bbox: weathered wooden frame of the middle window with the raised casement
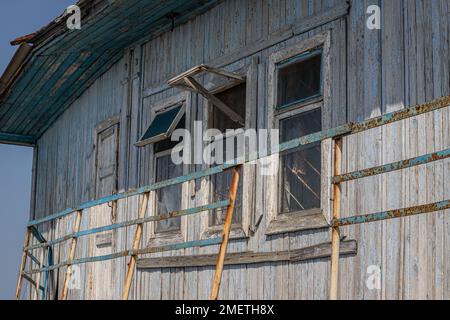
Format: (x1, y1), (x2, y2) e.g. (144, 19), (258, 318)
(200, 58), (259, 239)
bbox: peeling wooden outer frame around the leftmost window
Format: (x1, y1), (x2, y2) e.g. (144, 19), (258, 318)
(144, 93), (190, 247)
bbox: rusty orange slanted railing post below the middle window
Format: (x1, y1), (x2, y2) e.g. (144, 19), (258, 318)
(211, 166), (241, 300)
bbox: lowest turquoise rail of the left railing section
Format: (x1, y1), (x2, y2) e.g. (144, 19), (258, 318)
(24, 237), (222, 275)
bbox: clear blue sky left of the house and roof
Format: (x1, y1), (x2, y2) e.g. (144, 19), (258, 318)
(0, 0), (76, 299)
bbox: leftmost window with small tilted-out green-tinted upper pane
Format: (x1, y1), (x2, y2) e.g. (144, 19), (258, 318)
(135, 94), (189, 241)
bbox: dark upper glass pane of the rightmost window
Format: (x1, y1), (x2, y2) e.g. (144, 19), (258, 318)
(277, 53), (322, 108)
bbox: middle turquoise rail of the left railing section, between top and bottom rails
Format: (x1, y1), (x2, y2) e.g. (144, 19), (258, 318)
(23, 200), (230, 251)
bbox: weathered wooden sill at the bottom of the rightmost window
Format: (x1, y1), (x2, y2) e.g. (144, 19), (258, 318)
(265, 209), (329, 236)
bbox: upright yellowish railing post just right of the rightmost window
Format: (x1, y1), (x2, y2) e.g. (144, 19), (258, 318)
(330, 138), (342, 300)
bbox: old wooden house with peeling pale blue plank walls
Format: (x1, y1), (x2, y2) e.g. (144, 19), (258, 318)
(0, 0), (450, 299)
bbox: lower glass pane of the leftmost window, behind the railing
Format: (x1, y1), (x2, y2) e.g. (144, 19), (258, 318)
(155, 154), (183, 232)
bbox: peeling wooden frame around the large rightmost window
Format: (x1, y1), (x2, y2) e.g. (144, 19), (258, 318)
(266, 31), (331, 236)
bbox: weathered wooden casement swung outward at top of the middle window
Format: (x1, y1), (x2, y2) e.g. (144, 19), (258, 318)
(168, 64), (245, 127)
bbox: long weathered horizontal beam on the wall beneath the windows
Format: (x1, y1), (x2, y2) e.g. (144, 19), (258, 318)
(136, 240), (357, 269)
